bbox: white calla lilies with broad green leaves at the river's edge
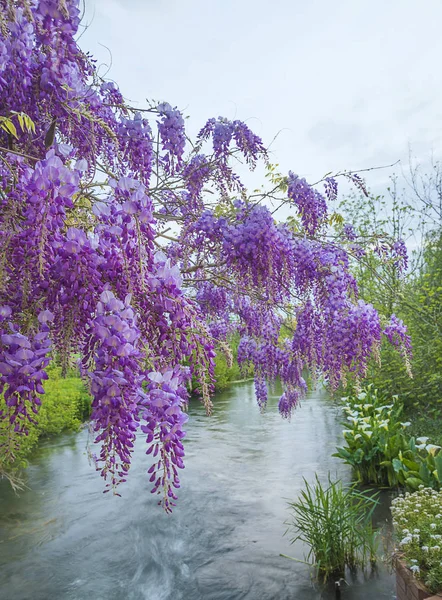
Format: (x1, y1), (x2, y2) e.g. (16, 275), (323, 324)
(334, 385), (442, 490)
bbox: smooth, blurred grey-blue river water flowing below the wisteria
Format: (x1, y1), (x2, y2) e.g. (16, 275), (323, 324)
(0, 382), (395, 600)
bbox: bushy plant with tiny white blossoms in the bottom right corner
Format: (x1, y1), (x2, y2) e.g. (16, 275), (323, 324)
(391, 486), (442, 593)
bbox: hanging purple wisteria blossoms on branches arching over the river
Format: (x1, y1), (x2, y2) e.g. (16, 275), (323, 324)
(0, 0), (410, 511)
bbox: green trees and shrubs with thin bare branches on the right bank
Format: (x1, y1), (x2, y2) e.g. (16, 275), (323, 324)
(341, 185), (442, 444)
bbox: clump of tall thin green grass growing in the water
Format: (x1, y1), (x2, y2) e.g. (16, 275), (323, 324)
(287, 475), (377, 579)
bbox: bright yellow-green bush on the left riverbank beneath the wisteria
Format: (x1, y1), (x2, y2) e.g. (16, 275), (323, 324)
(0, 367), (91, 478)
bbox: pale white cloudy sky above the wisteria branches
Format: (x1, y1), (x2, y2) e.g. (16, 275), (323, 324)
(80, 0), (442, 193)
